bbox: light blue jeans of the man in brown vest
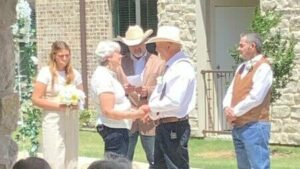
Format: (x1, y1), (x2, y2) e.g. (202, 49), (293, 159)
(232, 122), (271, 169)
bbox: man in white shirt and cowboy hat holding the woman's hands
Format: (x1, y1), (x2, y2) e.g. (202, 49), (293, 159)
(140, 26), (196, 169)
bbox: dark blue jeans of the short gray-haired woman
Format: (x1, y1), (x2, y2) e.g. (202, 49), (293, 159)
(96, 125), (129, 157)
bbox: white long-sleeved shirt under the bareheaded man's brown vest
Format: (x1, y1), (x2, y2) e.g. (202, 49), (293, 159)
(223, 54), (273, 117)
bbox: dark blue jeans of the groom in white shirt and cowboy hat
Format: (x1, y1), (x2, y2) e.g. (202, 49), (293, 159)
(154, 120), (191, 169)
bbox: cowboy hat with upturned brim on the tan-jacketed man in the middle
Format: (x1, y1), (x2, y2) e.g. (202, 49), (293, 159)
(118, 25), (153, 46)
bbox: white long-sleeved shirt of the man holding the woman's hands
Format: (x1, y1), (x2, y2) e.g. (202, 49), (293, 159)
(149, 51), (196, 120)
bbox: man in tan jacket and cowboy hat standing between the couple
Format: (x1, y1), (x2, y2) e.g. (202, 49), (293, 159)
(119, 25), (165, 168)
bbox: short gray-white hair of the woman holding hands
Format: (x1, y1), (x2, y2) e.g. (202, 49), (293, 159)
(95, 40), (121, 65)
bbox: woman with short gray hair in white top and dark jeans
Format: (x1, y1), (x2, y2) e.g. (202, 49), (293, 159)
(91, 40), (145, 156)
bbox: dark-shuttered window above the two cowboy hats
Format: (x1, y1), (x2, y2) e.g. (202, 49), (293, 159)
(113, 0), (157, 36)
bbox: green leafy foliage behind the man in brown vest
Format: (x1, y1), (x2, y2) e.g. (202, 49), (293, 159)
(230, 9), (296, 102)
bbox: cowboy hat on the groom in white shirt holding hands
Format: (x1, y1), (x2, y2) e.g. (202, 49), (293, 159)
(146, 26), (181, 45)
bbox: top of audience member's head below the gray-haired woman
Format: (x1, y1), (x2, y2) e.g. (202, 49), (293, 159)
(88, 152), (132, 169)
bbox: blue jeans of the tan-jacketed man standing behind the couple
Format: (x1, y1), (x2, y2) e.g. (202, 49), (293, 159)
(127, 131), (155, 169)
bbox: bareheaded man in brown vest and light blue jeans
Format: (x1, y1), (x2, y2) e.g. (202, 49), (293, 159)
(223, 33), (273, 169)
